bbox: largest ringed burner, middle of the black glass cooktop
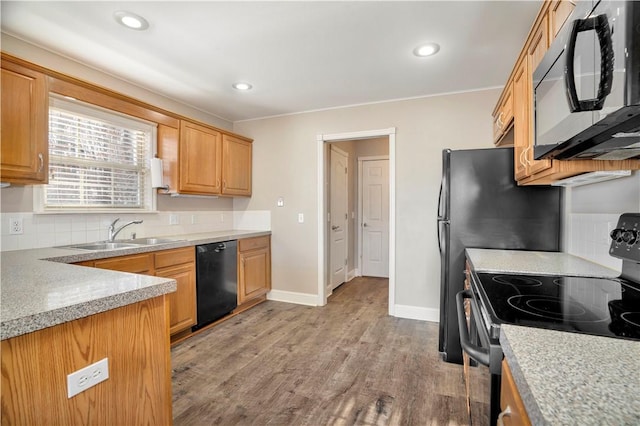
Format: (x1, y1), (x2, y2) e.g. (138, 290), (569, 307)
(507, 294), (608, 322)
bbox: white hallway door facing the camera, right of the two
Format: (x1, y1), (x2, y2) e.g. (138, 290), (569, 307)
(360, 160), (389, 277)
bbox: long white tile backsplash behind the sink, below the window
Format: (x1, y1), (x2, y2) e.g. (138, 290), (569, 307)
(0, 211), (271, 251)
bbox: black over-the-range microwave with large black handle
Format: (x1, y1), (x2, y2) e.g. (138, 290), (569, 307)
(532, 0), (640, 160)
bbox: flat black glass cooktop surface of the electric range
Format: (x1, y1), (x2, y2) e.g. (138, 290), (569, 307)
(477, 273), (640, 340)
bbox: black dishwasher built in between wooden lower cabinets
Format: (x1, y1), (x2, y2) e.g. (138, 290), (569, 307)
(192, 240), (238, 331)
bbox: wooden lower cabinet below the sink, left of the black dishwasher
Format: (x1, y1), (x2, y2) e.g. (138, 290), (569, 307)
(85, 247), (197, 334)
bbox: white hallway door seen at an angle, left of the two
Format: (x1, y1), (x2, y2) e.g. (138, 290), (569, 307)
(328, 146), (349, 292)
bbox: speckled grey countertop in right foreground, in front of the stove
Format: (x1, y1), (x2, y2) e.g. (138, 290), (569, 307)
(500, 324), (640, 425)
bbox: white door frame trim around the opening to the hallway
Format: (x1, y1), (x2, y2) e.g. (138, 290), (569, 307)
(316, 127), (396, 316)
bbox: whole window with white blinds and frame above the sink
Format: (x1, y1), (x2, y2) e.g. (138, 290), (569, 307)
(39, 96), (156, 212)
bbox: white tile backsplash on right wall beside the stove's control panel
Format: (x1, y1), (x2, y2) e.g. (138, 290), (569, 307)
(565, 213), (622, 272)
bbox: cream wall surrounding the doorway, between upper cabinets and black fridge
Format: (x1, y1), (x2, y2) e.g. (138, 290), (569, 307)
(234, 90), (499, 317)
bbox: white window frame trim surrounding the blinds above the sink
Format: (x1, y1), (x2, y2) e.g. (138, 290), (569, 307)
(33, 93), (158, 214)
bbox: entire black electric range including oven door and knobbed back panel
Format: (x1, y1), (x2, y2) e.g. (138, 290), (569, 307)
(457, 213), (640, 424)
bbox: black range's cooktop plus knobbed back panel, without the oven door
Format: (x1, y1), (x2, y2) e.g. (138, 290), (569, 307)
(472, 213), (640, 340)
